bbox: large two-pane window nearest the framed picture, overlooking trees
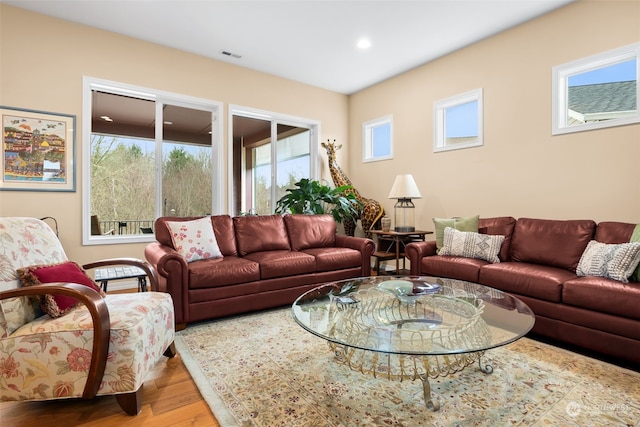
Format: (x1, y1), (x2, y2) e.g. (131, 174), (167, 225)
(82, 78), (222, 245)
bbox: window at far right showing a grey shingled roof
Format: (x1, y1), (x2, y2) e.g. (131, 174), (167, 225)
(552, 43), (640, 135)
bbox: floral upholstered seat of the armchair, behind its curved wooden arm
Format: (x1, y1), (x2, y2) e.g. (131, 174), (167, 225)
(0, 292), (175, 400)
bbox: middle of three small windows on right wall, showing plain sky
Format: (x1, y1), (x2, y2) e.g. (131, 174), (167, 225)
(433, 89), (483, 152)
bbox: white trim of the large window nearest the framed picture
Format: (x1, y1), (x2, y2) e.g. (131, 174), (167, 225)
(82, 76), (224, 245)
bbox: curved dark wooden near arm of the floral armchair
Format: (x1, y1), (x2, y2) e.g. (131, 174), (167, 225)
(0, 282), (111, 399)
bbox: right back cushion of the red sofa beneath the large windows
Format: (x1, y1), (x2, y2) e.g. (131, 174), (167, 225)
(284, 214), (336, 251)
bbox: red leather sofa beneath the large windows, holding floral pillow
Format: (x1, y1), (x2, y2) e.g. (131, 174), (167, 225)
(145, 215), (375, 330)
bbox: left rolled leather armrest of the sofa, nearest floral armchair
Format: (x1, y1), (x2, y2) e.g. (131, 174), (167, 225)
(144, 242), (189, 325)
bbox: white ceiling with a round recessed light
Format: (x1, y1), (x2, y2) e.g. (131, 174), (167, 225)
(5, 0), (574, 94)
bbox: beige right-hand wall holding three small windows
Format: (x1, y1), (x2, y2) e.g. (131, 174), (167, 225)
(348, 1), (640, 234)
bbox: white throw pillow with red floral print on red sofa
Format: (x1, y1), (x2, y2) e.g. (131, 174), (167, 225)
(166, 217), (222, 262)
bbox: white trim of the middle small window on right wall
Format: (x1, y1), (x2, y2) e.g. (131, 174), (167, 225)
(433, 88), (484, 153)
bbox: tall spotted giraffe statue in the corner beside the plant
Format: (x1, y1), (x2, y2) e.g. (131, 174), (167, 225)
(321, 140), (384, 238)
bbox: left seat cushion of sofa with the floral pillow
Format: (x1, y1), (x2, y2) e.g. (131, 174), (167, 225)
(188, 256), (260, 289)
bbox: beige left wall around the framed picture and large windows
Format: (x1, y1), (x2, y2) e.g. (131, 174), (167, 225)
(0, 4), (348, 263)
